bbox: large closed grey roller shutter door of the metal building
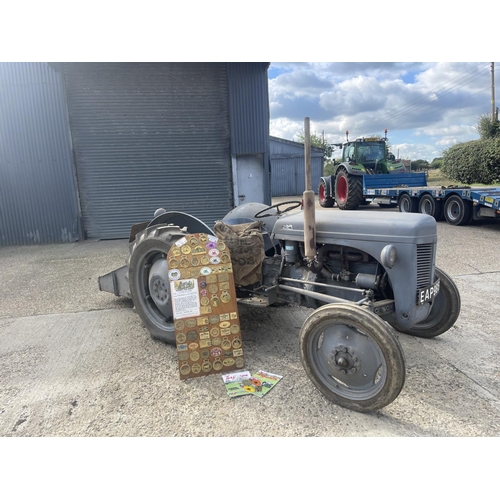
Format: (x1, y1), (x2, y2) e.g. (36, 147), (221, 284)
(63, 63), (233, 239)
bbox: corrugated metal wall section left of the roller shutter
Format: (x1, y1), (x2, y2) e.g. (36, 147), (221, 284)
(0, 62), (81, 245)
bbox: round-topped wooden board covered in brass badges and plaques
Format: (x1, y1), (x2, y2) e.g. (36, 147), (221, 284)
(167, 233), (245, 379)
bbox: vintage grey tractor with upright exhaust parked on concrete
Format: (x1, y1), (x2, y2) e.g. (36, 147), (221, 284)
(99, 118), (460, 412)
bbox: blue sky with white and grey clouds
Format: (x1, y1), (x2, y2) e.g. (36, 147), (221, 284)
(268, 62), (500, 162)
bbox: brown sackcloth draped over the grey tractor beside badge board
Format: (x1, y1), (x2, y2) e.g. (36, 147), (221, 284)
(214, 221), (265, 286)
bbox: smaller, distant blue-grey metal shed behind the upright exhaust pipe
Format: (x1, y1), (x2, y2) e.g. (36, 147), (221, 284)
(269, 137), (324, 196)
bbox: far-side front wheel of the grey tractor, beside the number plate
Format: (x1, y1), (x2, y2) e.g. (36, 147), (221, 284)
(393, 267), (461, 339)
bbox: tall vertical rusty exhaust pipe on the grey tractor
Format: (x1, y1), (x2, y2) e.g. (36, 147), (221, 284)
(303, 117), (316, 265)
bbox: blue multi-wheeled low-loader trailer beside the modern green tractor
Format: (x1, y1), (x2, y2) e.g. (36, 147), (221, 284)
(363, 172), (500, 226)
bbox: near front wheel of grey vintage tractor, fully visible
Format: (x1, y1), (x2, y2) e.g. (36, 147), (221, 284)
(300, 304), (405, 412)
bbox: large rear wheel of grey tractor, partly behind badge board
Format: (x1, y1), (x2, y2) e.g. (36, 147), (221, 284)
(128, 226), (186, 344)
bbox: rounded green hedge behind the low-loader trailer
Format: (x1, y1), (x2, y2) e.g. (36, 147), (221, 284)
(441, 138), (500, 184)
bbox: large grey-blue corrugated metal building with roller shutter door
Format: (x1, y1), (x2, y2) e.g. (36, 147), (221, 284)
(0, 63), (271, 245)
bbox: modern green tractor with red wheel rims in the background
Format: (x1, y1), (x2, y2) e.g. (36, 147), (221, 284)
(318, 129), (406, 210)
